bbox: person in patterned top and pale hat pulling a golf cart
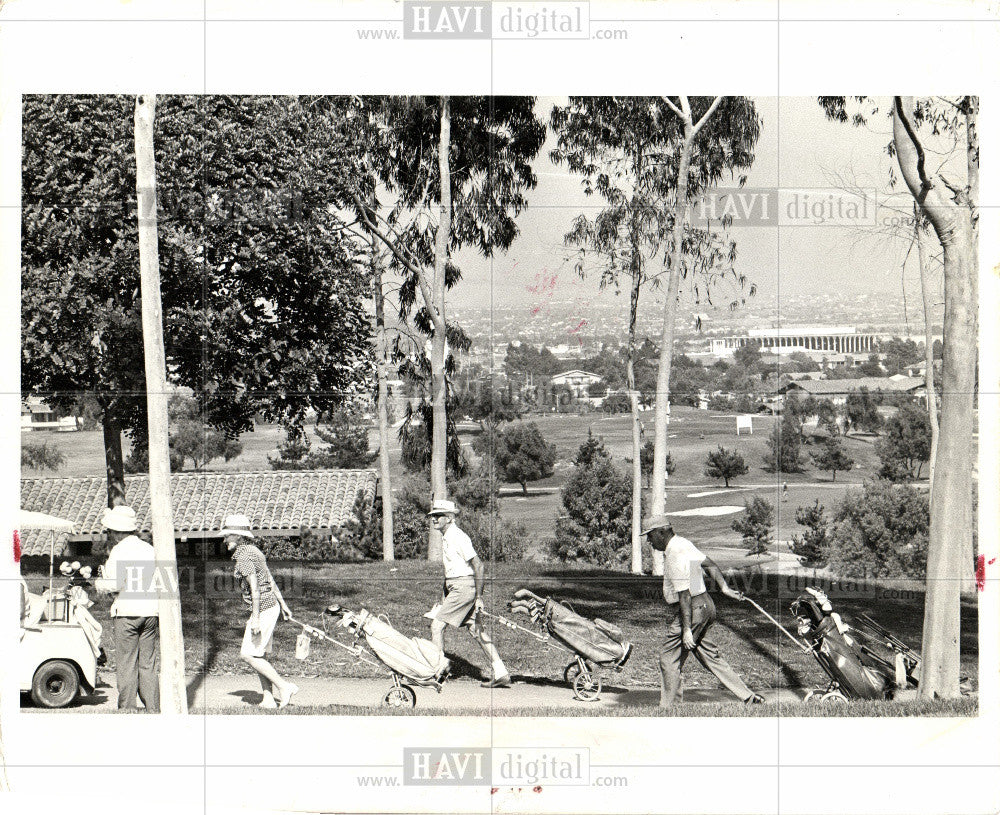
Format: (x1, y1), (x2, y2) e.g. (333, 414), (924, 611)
(220, 515), (299, 709)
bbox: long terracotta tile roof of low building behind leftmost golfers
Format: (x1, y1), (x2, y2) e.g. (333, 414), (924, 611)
(21, 470), (377, 555)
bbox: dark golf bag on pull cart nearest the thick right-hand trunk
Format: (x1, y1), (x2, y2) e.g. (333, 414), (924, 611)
(791, 588), (904, 699)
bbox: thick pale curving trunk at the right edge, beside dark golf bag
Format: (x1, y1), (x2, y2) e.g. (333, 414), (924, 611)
(893, 92), (979, 698)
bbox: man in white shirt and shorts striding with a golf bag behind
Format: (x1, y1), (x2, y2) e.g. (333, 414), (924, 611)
(424, 501), (511, 688)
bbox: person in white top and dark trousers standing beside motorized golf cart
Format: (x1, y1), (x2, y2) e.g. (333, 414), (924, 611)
(94, 506), (160, 713)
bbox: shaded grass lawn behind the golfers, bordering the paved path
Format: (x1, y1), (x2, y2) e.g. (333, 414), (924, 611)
(29, 561), (977, 700)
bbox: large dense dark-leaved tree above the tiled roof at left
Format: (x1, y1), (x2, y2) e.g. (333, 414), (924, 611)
(21, 96), (369, 504)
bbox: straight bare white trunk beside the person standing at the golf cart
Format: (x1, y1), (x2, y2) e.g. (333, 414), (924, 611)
(135, 94), (187, 714)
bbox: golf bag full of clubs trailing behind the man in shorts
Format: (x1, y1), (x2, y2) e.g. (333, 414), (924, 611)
(510, 589), (632, 668)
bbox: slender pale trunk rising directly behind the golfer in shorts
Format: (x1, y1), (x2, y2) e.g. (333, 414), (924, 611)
(427, 96), (451, 561)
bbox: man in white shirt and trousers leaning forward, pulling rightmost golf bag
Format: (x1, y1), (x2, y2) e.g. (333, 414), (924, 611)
(643, 515), (764, 708)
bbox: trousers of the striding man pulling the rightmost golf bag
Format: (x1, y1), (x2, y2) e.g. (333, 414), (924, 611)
(660, 592), (753, 707)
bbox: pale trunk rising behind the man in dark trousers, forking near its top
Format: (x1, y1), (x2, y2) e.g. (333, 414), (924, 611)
(649, 132), (694, 575)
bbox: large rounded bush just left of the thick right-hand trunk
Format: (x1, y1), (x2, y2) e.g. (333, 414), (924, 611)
(827, 479), (930, 578)
